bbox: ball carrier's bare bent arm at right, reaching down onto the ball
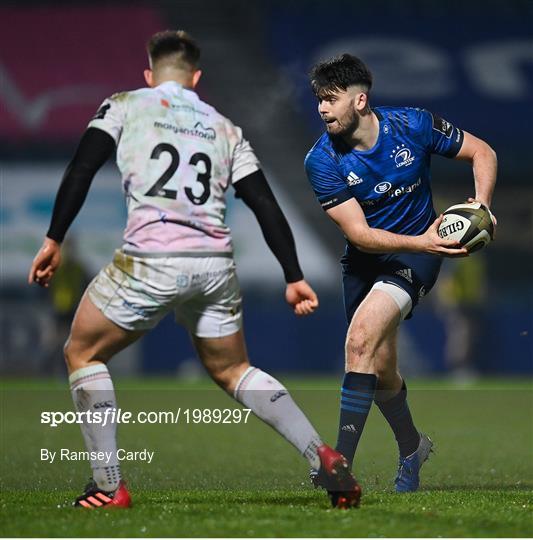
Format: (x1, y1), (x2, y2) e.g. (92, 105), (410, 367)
(455, 131), (498, 221)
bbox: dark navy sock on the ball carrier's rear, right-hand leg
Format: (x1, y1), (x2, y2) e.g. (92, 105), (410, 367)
(376, 381), (420, 457)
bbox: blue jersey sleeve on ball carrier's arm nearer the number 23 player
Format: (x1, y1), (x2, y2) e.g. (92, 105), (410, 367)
(304, 149), (353, 210)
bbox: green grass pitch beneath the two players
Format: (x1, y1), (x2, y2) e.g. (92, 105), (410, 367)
(0, 379), (533, 537)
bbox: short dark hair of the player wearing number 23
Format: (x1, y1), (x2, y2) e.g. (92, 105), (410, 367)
(147, 30), (200, 71)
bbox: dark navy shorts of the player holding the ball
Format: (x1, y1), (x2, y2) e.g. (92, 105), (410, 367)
(341, 246), (442, 323)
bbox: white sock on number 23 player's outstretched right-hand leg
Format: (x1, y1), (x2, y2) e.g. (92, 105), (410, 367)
(233, 367), (323, 470)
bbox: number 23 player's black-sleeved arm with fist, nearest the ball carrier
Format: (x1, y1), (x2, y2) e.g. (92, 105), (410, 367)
(234, 169), (318, 315)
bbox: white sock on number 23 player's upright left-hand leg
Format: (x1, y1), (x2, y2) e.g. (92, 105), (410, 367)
(69, 364), (121, 491)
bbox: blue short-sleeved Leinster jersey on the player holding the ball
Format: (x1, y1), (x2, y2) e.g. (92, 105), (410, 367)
(305, 107), (463, 235)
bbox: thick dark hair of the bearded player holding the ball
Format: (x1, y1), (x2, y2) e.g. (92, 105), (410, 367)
(309, 54), (372, 97)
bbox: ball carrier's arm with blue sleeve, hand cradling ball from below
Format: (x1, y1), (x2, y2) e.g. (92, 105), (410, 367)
(305, 150), (467, 257)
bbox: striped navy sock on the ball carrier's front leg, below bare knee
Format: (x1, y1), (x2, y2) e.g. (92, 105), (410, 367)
(336, 371), (378, 463)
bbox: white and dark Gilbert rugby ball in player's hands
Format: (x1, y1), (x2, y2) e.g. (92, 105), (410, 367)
(439, 202), (494, 253)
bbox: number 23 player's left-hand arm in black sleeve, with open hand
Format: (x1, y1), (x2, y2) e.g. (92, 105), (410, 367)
(28, 127), (115, 287)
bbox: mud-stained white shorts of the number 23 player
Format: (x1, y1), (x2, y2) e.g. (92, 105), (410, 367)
(87, 250), (242, 338)
